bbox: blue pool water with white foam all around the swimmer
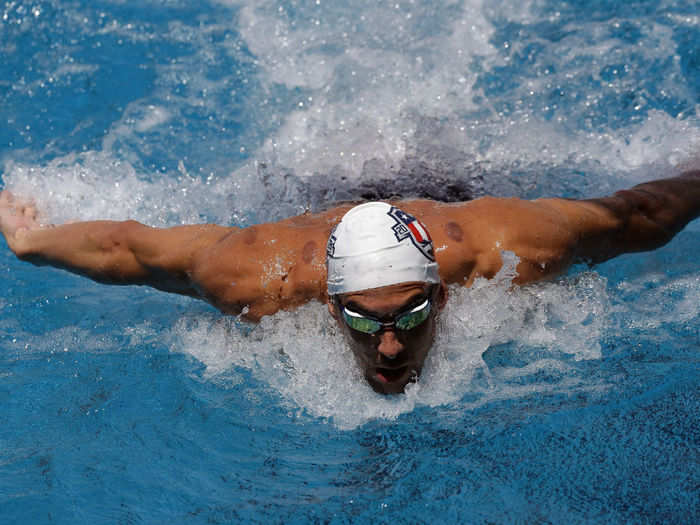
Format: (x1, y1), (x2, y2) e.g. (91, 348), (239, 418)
(0, 0), (700, 524)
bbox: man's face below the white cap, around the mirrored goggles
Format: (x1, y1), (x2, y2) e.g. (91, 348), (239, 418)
(328, 282), (447, 394)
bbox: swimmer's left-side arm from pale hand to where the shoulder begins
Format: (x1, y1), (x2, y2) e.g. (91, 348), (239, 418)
(0, 191), (230, 296)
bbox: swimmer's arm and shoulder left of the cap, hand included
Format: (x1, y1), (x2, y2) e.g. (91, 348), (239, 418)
(0, 192), (340, 321)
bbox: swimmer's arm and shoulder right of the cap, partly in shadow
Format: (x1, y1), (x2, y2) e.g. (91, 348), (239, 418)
(442, 170), (700, 284)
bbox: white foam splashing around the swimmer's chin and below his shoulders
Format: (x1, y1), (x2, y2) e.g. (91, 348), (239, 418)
(173, 255), (609, 428)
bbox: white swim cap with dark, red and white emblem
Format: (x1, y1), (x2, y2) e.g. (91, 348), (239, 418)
(326, 202), (440, 295)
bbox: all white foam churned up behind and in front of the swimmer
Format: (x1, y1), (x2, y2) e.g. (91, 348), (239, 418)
(0, 0), (700, 427)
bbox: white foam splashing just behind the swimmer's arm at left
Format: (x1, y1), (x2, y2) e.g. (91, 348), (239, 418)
(3, 149), (305, 227)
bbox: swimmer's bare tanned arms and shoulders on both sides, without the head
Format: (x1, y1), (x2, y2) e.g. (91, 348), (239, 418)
(0, 169), (700, 322)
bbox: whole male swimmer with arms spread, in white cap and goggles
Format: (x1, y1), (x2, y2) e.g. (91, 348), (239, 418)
(0, 170), (700, 394)
